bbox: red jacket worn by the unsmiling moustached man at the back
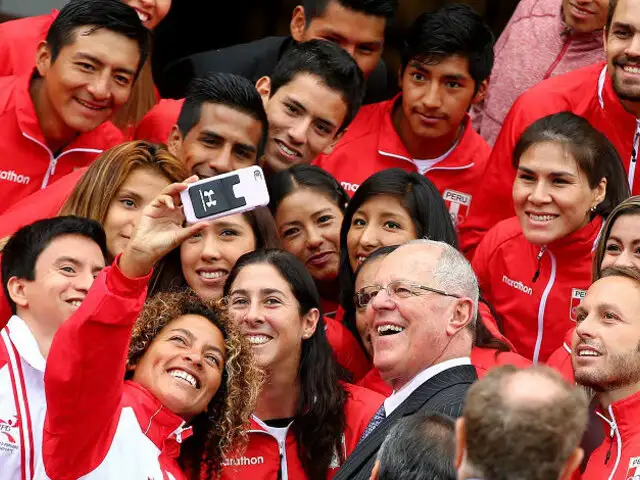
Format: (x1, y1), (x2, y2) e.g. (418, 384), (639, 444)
(313, 96), (491, 234)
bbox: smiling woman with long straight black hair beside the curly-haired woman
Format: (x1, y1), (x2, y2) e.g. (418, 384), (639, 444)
(222, 250), (383, 480)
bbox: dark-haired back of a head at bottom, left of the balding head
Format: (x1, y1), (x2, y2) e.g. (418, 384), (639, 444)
(378, 413), (456, 480)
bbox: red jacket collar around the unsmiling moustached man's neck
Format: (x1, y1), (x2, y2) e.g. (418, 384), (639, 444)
(378, 93), (474, 170)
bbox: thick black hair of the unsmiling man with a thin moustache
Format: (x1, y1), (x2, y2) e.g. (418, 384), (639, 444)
(402, 4), (494, 90)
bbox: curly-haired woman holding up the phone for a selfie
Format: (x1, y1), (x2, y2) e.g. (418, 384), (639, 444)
(36, 178), (259, 480)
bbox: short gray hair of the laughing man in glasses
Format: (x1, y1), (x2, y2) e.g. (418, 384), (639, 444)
(407, 238), (480, 320)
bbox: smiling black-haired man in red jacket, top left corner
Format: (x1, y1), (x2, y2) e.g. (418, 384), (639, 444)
(0, 0), (149, 212)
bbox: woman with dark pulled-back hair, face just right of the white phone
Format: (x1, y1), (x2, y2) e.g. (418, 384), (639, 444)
(267, 165), (369, 380)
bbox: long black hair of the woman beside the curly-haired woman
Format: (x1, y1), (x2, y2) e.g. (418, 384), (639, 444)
(224, 249), (347, 480)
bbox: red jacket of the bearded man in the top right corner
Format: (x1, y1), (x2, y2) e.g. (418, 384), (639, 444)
(460, 63), (640, 258)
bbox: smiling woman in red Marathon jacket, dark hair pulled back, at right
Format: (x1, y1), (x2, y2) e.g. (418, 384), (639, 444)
(473, 112), (629, 362)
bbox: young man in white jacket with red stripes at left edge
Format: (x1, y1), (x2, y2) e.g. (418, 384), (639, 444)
(0, 217), (107, 480)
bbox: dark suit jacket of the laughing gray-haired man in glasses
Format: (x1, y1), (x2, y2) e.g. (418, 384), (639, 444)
(333, 365), (478, 480)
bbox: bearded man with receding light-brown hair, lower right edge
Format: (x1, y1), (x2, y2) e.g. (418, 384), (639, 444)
(571, 267), (640, 480)
